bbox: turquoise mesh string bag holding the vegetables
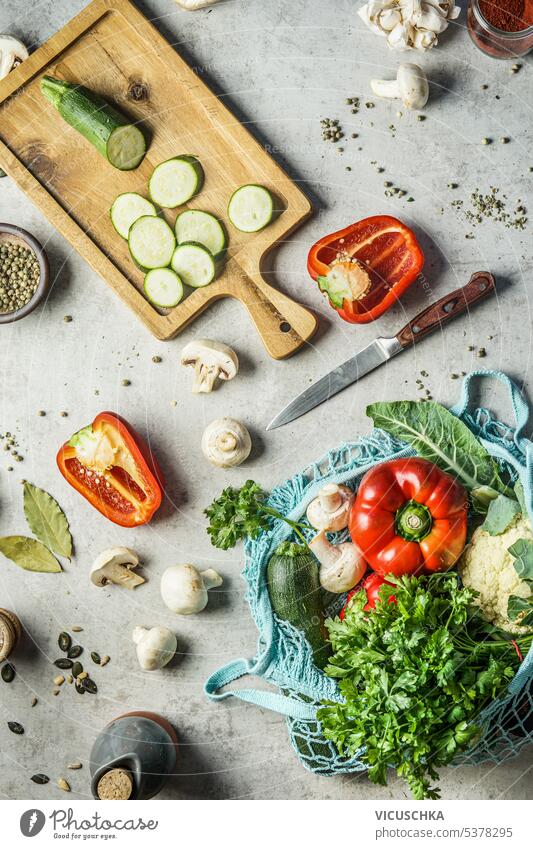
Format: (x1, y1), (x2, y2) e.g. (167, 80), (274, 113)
(204, 371), (533, 775)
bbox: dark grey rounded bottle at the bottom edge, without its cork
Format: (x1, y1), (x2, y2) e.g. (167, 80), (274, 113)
(90, 711), (178, 799)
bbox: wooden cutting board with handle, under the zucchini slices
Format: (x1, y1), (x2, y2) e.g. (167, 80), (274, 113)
(0, 0), (316, 359)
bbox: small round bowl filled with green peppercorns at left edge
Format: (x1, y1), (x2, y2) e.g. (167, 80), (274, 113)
(0, 223), (50, 324)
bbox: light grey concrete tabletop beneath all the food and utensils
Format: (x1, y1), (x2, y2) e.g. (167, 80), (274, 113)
(0, 0), (533, 799)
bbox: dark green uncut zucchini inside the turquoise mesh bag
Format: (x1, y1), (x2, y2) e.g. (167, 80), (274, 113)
(267, 543), (329, 669)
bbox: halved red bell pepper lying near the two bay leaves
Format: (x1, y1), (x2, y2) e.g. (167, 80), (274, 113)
(57, 413), (163, 528)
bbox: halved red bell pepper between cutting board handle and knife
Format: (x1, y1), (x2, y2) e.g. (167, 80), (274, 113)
(307, 215), (424, 324)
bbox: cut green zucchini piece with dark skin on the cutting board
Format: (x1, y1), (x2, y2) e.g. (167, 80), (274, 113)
(41, 76), (146, 171)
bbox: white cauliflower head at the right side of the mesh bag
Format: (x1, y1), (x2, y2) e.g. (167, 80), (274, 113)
(459, 515), (533, 634)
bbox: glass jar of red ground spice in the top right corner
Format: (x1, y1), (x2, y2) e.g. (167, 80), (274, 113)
(467, 0), (533, 59)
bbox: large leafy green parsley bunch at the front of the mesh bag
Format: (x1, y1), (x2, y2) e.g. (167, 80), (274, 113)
(318, 572), (531, 799)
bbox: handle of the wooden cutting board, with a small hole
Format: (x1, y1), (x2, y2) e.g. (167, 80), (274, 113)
(231, 266), (317, 360)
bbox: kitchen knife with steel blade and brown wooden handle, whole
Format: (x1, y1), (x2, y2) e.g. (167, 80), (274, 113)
(267, 271), (496, 430)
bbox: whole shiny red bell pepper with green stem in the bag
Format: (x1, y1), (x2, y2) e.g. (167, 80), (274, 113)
(349, 457), (468, 575)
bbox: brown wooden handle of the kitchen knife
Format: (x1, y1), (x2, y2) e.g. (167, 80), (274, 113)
(396, 271), (496, 348)
